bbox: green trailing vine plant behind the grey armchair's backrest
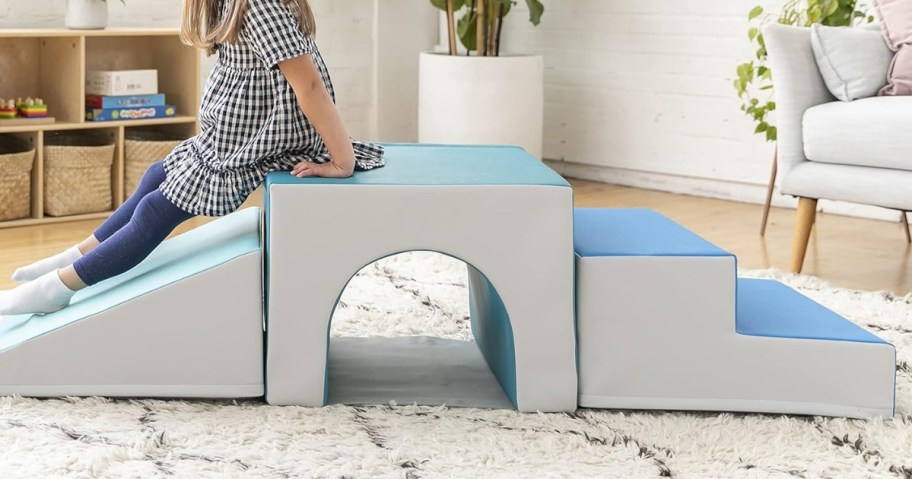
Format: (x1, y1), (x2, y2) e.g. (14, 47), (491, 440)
(734, 0), (874, 141)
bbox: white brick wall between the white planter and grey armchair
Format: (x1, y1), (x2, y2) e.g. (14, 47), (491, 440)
(503, 0), (772, 196)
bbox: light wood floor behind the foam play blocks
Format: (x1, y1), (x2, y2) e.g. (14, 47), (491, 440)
(0, 180), (912, 294)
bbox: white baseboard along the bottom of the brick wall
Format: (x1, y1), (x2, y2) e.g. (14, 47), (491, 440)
(545, 159), (899, 222)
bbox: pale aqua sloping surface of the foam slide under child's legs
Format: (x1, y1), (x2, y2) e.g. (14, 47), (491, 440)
(0, 208), (260, 351)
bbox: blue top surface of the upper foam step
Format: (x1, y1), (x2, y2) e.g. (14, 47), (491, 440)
(573, 208), (732, 257)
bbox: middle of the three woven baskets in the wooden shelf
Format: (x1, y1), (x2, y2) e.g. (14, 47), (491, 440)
(44, 134), (114, 216)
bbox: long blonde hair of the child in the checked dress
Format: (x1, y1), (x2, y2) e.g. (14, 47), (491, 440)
(180, 0), (317, 55)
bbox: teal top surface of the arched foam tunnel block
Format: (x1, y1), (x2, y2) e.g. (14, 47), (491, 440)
(266, 144), (570, 190)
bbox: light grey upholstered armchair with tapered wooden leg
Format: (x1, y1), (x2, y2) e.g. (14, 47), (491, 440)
(763, 24), (912, 273)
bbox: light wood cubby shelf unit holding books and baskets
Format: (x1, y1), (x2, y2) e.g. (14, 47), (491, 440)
(0, 29), (200, 228)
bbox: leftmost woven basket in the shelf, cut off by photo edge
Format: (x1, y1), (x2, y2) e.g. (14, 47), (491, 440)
(0, 138), (35, 221)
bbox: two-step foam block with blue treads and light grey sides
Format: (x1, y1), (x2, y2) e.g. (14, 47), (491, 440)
(574, 210), (895, 417)
